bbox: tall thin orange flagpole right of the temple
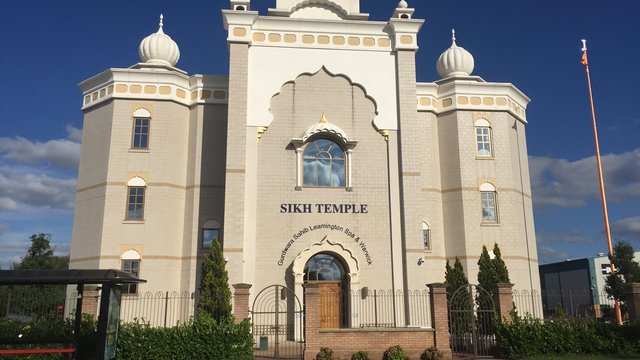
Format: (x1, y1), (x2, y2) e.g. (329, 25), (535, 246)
(582, 39), (622, 326)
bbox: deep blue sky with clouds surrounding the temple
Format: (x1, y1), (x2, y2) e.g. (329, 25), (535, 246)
(0, 0), (640, 269)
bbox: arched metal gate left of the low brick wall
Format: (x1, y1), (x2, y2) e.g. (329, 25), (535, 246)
(251, 285), (304, 360)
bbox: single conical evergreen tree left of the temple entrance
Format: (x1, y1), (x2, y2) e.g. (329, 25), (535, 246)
(198, 241), (231, 320)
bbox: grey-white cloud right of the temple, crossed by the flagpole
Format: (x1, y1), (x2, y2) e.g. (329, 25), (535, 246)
(529, 149), (640, 207)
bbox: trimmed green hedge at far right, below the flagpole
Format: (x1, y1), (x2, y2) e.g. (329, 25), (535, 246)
(496, 317), (640, 359)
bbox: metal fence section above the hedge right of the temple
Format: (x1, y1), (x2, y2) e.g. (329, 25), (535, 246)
(513, 289), (615, 322)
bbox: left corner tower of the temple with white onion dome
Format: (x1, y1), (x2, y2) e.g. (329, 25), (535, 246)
(70, 16), (227, 295)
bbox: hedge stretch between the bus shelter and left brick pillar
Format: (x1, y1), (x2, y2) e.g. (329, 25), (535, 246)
(118, 315), (253, 360)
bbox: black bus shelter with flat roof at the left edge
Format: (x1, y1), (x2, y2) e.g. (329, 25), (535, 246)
(0, 269), (147, 359)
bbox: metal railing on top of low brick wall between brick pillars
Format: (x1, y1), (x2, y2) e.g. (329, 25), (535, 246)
(320, 288), (432, 328)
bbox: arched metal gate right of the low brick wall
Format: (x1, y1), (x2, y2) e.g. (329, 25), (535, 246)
(449, 285), (497, 359)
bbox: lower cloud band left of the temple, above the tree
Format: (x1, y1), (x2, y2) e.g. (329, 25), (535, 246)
(0, 166), (76, 211)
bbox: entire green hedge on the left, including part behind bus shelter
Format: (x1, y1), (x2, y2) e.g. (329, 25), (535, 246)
(0, 314), (253, 360)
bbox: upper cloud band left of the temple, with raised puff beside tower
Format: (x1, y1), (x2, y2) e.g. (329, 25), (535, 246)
(0, 125), (82, 169)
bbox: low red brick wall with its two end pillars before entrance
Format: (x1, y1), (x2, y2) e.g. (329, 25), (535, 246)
(304, 284), (451, 360)
